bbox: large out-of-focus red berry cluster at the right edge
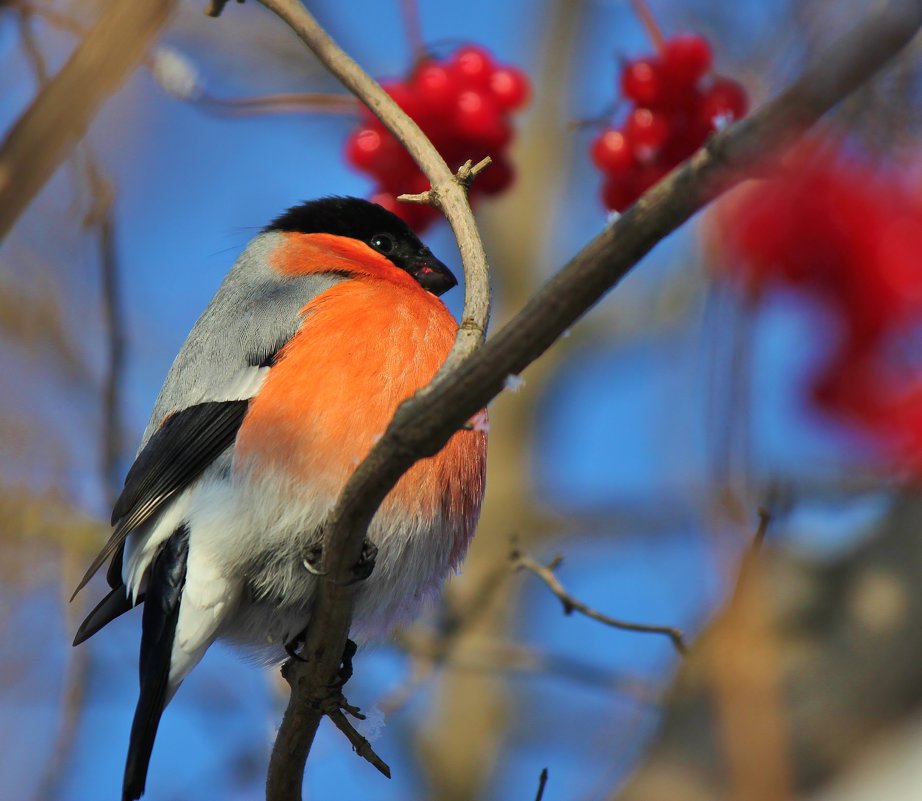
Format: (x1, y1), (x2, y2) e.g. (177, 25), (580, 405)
(718, 143), (922, 474)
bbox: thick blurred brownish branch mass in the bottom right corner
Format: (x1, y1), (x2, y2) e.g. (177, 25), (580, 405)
(612, 493), (922, 801)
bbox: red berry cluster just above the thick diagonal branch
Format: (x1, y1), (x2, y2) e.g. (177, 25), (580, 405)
(591, 34), (748, 212)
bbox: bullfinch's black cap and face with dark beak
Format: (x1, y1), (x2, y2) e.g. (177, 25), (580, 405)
(263, 197), (458, 295)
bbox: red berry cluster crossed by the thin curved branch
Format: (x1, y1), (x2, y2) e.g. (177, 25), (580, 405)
(346, 45), (530, 231)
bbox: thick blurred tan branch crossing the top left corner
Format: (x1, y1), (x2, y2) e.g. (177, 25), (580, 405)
(0, 0), (176, 240)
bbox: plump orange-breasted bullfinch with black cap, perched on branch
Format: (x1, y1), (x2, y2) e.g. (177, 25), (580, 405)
(74, 197), (487, 801)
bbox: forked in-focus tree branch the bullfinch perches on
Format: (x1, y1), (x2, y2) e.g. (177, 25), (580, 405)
(232, 0), (922, 801)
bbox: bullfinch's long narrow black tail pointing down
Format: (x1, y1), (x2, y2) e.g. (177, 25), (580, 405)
(122, 526), (189, 801)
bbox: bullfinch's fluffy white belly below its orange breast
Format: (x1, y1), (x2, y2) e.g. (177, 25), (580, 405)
(126, 467), (460, 662)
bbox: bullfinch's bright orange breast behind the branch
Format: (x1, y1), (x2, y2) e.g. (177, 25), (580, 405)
(235, 278), (486, 536)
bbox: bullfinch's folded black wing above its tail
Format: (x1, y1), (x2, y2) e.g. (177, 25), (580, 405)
(74, 400), (249, 600)
